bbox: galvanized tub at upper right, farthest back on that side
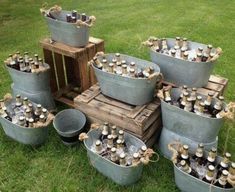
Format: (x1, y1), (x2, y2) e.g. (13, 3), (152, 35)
(150, 38), (218, 87)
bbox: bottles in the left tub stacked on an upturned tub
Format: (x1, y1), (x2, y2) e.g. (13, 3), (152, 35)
(5, 51), (46, 73)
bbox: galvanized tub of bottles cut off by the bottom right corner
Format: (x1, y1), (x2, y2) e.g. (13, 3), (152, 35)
(174, 157), (235, 192)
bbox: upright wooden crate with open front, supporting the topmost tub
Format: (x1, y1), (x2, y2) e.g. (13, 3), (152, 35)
(40, 37), (104, 100)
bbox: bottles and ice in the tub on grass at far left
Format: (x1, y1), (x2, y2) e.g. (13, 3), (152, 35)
(0, 95), (48, 128)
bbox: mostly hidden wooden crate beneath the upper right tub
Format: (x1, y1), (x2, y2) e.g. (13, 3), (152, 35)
(162, 75), (228, 97)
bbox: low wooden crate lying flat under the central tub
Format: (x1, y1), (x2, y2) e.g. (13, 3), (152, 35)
(74, 84), (162, 146)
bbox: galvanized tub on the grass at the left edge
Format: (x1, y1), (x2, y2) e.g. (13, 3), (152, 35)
(0, 100), (48, 146)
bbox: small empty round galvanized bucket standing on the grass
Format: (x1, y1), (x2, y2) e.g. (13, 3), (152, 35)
(53, 109), (86, 146)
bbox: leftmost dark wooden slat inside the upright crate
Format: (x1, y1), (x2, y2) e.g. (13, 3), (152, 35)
(43, 49), (58, 92)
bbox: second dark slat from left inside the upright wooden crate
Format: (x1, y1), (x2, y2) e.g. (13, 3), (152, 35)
(54, 53), (66, 88)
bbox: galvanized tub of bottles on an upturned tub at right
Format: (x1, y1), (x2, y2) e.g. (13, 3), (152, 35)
(161, 88), (223, 143)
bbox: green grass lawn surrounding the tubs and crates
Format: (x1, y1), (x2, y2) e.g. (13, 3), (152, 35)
(0, 0), (235, 192)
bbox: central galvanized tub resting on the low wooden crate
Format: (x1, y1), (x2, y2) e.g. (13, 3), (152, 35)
(93, 53), (162, 105)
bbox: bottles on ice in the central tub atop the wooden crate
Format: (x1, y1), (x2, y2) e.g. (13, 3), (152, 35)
(93, 53), (154, 78)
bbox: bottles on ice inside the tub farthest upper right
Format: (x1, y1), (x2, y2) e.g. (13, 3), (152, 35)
(149, 37), (216, 62)
